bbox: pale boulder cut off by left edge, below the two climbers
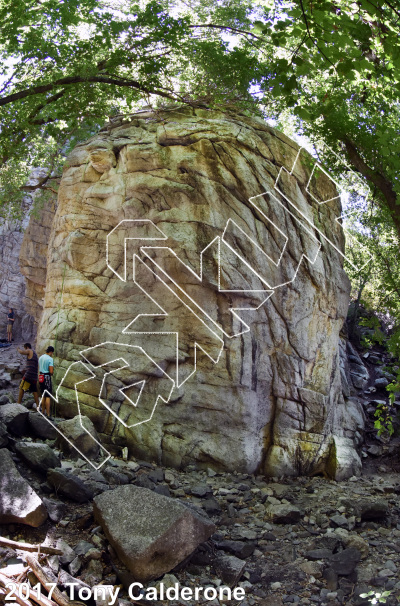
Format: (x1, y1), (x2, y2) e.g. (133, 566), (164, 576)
(0, 448), (47, 528)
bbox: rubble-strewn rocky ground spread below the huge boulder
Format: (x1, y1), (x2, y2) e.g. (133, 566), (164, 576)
(0, 380), (400, 606)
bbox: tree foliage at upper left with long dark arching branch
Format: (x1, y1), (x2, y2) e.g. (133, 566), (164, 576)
(0, 0), (258, 217)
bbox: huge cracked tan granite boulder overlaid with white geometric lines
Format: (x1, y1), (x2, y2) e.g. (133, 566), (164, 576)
(31, 109), (363, 479)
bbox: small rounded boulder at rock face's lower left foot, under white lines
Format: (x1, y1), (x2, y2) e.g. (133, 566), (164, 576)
(57, 415), (100, 458)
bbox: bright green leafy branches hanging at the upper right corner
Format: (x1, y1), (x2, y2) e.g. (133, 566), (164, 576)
(260, 0), (400, 245)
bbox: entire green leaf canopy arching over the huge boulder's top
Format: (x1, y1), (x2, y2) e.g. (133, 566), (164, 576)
(0, 0), (400, 242)
